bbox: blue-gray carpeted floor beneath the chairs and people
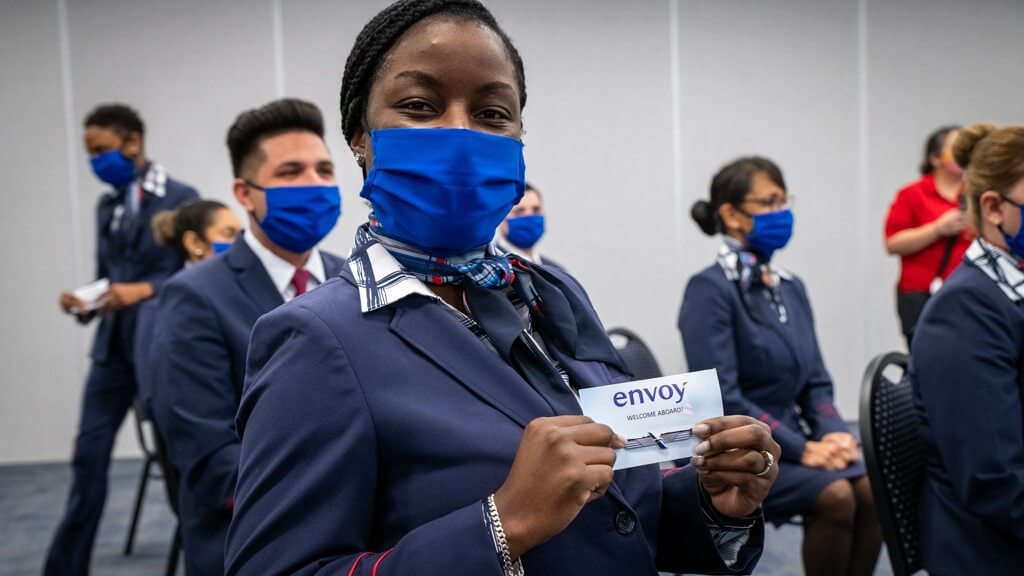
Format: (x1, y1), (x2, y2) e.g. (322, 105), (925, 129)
(0, 460), (892, 576)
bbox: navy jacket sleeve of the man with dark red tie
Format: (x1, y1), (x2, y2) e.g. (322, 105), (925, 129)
(151, 277), (239, 508)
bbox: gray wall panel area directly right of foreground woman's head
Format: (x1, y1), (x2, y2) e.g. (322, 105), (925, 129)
(490, 0), (680, 369)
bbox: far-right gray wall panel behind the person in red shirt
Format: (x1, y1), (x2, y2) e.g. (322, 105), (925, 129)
(858, 0), (1024, 366)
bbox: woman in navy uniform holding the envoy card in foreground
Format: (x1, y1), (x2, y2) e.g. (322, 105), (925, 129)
(226, 0), (779, 576)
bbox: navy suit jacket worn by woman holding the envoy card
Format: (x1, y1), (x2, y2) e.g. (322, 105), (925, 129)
(226, 266), (763, 576)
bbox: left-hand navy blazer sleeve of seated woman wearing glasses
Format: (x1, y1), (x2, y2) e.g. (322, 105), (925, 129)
(679, 275), (807, 462)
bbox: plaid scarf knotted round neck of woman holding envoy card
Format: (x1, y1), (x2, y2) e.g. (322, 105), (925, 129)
(364, 214), (516, 290)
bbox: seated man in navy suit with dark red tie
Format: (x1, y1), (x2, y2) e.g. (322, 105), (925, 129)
(153, 99), (344, 576)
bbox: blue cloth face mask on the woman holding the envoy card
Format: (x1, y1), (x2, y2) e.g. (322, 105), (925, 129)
(359, 128), (526, 256)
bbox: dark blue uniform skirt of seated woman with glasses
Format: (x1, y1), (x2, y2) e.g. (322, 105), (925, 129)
(764, 461), (867, 526)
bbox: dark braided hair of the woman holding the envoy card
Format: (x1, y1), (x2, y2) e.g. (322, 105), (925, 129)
(341, 0), (526, 141)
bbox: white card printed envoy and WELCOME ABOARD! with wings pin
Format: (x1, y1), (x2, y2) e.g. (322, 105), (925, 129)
(580, 370), (723, 470)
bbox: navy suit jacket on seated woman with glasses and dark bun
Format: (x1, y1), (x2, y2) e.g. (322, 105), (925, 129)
(679, 263), (849, 462)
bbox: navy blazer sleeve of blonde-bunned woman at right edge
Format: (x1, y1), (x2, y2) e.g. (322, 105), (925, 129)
(912, 290), (1024, 540)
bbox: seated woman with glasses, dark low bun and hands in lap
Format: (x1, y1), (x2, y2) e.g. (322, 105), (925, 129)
(679, 157), (882, 576)
